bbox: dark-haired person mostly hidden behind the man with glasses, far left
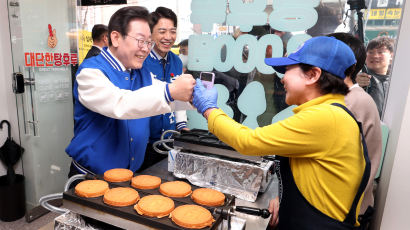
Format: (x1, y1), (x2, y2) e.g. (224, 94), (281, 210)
(84, 24), (108, 59)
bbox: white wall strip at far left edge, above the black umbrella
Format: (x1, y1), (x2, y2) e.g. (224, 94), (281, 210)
(0, 1), (22, 175)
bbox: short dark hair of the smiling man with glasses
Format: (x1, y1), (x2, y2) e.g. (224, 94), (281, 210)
(108, 6), (152, 46)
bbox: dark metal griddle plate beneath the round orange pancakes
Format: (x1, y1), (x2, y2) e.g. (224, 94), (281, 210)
(63, 175), (235, 229)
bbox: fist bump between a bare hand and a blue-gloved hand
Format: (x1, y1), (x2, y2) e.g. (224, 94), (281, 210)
(169, 74), (218, 115)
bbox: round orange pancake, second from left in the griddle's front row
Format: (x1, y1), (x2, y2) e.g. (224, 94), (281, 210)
(103, 187), (140, 207)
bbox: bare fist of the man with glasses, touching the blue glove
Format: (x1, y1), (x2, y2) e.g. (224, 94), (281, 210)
(168, 74), (195, 101)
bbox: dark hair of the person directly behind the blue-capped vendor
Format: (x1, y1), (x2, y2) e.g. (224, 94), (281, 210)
(327, 33), (367, 83)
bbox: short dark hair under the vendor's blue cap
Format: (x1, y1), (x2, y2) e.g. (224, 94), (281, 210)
(299, 63), (354, 95)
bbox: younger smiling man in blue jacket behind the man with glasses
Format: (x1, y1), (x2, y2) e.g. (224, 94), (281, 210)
(141, 7), (187, 169)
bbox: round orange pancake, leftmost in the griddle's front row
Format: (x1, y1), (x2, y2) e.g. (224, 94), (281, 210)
(74, 180), (109, 198)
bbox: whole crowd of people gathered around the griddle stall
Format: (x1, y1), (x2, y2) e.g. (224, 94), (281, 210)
(66, 6), (394, 229)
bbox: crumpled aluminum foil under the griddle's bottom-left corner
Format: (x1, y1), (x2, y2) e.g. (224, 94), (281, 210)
(54, 211), (98, 230)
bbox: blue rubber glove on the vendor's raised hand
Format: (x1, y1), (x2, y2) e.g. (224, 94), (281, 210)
(192, 78), (218, 114)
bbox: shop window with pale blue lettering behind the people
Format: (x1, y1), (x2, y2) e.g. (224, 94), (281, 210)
(77, 0), (403, 128)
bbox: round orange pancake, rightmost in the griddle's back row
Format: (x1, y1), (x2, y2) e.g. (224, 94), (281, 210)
(191, 188), (225, 206)
